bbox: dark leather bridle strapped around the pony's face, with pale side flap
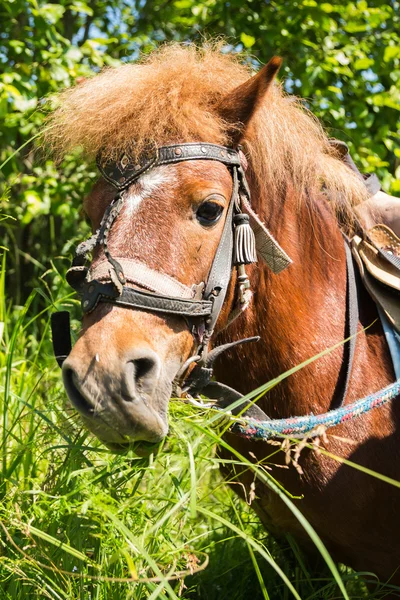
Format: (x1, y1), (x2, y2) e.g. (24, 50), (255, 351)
(52, 143), (291, 412)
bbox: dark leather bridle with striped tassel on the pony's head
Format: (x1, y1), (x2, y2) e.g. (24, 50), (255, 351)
(52, 143), (272, 408)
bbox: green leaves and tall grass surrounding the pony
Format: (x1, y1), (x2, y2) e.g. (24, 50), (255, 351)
(0, 0), (400, 600)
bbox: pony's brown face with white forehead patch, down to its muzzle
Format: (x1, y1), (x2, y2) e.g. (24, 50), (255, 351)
(63, 160), (238, 447)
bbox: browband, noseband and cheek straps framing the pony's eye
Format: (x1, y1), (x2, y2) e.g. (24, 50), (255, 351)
(77, 144), (249, 338)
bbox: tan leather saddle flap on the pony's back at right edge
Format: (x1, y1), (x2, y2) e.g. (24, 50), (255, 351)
(351, 224), (400, 334)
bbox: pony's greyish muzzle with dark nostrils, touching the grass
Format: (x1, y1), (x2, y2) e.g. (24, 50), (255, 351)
(63, 347), (168, 448)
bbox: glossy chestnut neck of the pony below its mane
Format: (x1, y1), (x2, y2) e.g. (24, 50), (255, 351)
(217, 189), (391, 417)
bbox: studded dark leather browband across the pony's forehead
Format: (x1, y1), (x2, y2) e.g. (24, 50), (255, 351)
(97, 142), (240, 191)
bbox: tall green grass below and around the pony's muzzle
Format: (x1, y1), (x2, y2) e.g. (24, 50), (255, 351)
(0, 253), (400, 600)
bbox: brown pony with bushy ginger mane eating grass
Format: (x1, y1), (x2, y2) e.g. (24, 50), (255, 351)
(47, 45), (400, 581)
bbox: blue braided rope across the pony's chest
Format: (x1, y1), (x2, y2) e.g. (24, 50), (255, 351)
(232, 379), (400, 440)
